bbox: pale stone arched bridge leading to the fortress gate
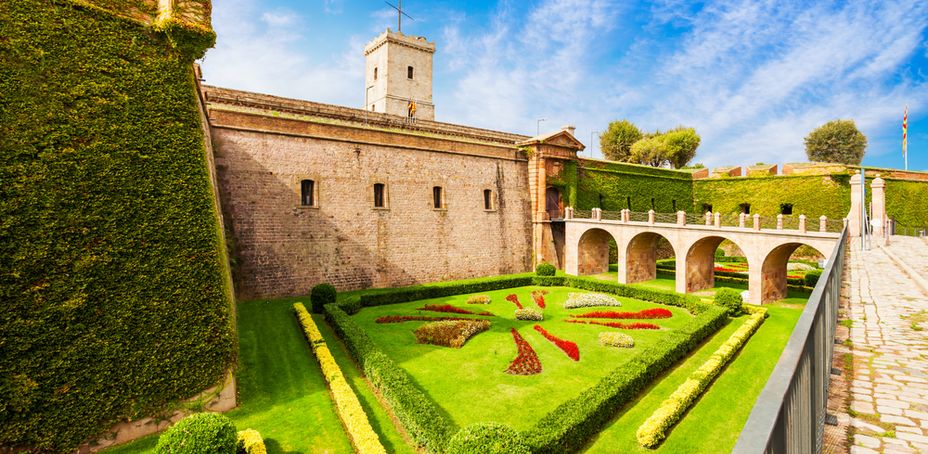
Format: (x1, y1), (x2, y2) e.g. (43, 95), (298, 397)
(564, 208), (843, 304)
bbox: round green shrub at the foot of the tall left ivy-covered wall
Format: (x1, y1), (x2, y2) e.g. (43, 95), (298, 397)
(158, 413), (238, 454)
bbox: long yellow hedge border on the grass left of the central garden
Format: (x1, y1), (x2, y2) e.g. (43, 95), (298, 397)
(293, 303), (387, 454)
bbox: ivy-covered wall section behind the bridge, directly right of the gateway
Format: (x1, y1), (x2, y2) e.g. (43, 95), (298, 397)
(573, 159), (693, 213)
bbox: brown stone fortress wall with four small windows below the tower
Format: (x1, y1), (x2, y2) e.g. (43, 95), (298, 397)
(207, 88), (531, 298)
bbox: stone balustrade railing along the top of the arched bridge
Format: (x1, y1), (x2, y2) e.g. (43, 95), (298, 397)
(565, 208), (846, 233)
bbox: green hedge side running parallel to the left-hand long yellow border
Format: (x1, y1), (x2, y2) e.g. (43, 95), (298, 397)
(325, 304), (454, 453)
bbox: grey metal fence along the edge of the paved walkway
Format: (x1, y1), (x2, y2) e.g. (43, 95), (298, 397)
(733, 229), (847, 454)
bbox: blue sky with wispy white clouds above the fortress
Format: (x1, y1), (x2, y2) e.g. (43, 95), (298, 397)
(203, 0), (928, 170)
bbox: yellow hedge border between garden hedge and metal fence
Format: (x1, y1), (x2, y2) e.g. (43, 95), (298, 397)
(635, 306), (767, 448)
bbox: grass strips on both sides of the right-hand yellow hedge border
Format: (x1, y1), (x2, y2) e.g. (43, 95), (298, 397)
(587, 303), (802, 453)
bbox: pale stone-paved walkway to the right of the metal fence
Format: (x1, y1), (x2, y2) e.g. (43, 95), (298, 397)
(848, 237), (928, 453)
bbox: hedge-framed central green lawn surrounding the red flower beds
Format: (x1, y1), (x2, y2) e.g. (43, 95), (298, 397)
(354, 287), (692, 430)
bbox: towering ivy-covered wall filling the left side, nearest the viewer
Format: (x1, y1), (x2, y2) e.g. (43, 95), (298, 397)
(0, 0), (236, 452)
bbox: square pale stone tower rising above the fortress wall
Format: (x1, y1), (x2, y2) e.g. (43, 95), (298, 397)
(364, 28), (435, 120)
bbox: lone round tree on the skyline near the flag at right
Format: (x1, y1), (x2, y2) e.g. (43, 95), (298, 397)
(805, 120), (867, 165)
